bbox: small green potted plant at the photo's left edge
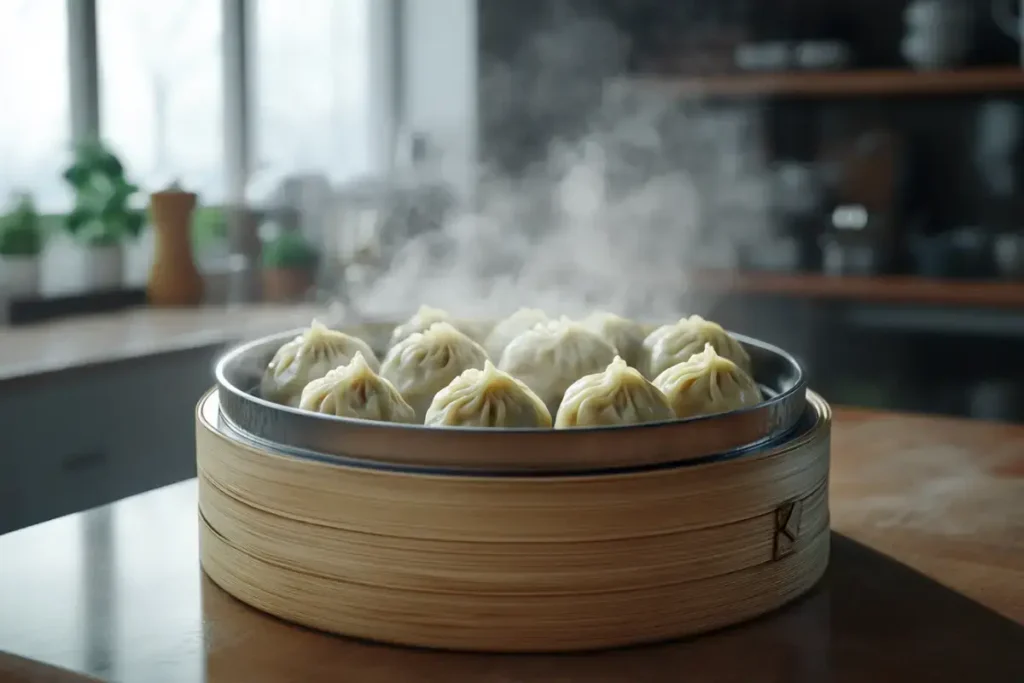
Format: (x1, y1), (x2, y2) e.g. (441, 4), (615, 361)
(0, 194), (45, 297)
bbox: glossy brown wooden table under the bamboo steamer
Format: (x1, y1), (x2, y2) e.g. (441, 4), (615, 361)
(0, 410), (1024, 683)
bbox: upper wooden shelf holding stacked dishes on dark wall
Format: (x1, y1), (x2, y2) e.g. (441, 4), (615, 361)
(629, 67), (1024, 97)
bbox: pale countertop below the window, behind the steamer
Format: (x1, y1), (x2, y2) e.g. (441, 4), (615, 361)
(0, 305), (327, 380)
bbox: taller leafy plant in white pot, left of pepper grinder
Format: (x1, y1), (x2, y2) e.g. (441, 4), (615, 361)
(63, 141), (145, 290)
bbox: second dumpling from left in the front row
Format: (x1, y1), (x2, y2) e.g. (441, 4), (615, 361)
(425, 360), (551, 429)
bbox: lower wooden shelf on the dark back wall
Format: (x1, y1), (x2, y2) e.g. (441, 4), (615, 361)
(696, 271), (1024, 311)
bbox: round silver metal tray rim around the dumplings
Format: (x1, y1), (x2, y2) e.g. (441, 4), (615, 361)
(215, 323), (807, 475)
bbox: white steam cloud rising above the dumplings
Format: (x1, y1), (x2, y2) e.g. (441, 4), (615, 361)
(344, 6), (764, 319)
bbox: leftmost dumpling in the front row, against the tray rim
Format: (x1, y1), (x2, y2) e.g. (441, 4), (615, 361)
(299, 351), (418, 424)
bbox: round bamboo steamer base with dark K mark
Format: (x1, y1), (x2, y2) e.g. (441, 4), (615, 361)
(197, 385), (831, 652)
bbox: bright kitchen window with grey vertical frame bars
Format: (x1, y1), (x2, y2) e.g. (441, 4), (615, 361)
(0, 0), (401, 280)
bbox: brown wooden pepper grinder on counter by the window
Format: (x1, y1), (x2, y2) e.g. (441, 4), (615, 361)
(146, 183), (203, 306)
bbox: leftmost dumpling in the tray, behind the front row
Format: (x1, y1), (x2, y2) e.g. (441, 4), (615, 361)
(260, 321), (379, 408)
